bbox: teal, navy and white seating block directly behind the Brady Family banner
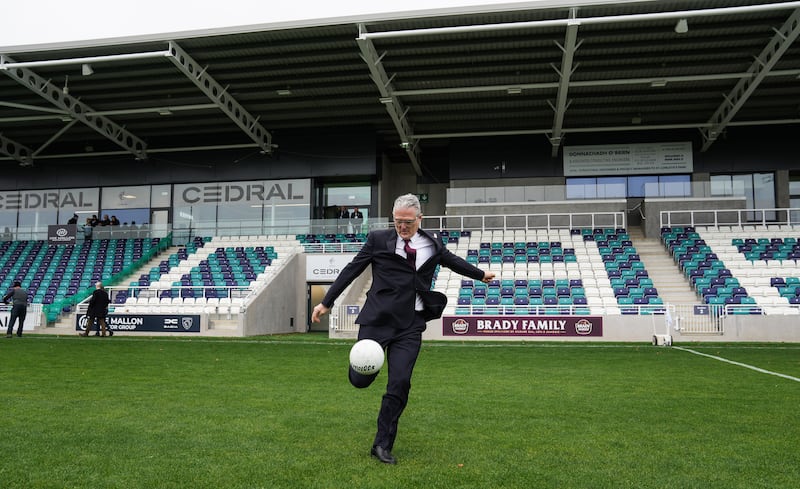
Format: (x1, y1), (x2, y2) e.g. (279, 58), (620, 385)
(434, 228), (664, 315)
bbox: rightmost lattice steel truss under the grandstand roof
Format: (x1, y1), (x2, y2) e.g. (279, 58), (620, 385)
(700, 9), (800, 151)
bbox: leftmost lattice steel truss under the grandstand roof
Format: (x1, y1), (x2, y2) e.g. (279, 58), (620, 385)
(0, 55), (147, 159)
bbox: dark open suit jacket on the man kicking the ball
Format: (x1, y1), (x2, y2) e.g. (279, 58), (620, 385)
(322, 229), (484, 329)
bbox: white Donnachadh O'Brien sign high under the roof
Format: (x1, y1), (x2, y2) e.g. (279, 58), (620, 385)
(564, 142), (694, 177)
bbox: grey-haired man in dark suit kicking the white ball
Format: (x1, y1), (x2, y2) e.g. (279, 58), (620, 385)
(311, 194), (495, 464)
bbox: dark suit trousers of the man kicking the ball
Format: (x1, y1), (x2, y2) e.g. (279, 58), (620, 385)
(350, 314), (426, 450)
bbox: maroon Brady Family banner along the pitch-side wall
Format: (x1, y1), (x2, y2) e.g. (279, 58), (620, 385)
(442, 316), (603, 337)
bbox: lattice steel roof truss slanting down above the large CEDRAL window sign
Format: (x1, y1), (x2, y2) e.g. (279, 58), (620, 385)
(164, 41), (274, 154)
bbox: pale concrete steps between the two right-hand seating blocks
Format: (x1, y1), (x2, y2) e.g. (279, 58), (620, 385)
(628, 227), (701, 304)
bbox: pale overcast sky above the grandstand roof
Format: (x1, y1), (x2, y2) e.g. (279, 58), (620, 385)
(0, 0), (559, 49)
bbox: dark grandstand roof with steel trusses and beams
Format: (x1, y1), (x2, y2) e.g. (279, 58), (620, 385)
(0, 0), (800, 173)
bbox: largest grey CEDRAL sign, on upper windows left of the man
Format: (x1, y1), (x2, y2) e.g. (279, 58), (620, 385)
(173, 179), (311, 207)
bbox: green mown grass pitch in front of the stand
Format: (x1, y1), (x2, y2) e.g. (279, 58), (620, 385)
(0, 334), (800, 489)
